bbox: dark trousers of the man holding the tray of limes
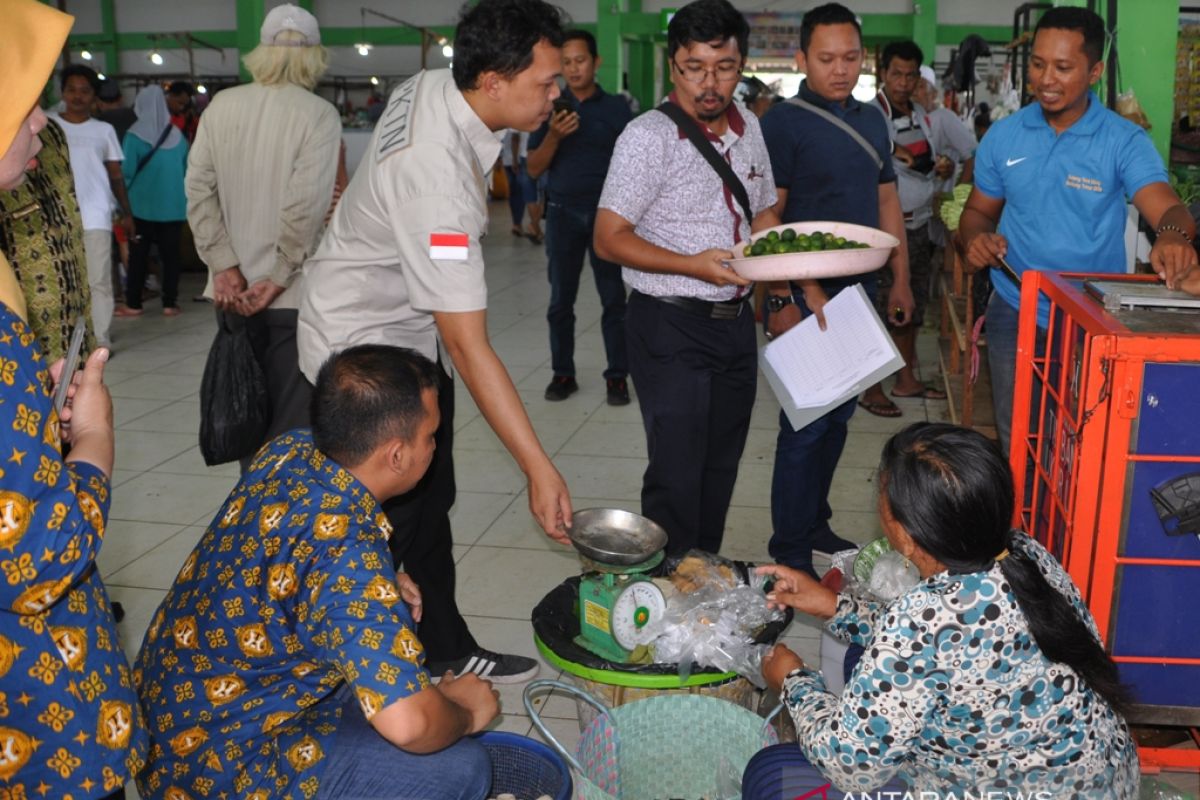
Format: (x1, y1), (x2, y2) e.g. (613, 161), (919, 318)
(625, 291), (758, 555)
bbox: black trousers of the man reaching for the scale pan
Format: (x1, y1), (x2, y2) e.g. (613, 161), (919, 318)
(383, 363), (479, 662)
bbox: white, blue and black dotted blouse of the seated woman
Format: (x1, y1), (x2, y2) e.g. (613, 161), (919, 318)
(782, 527), (1139, 799)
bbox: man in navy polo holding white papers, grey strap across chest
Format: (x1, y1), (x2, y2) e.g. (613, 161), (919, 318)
(762, 2), (913, 577)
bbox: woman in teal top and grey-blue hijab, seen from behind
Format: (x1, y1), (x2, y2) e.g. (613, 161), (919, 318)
(116, 84), (187, 317)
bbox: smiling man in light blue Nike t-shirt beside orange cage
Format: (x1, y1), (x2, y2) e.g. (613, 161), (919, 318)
(960, 7), (1196, 452)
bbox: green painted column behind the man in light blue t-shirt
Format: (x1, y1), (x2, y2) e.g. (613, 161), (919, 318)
(1117, 0), (1180, 161)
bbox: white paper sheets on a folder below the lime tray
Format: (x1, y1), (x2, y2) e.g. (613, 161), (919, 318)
(758, 284), (904, 431)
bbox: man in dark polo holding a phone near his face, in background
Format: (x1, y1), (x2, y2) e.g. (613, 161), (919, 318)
(526, 30), (632, 405)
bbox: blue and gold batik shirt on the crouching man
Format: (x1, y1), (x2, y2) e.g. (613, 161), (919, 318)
(134, 431), (430, 800)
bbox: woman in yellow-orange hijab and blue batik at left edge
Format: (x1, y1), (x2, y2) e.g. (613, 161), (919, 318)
(0, 0), (146, 800)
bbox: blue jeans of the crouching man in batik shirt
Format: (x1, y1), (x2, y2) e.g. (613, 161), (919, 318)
(317, 692), (492, 800)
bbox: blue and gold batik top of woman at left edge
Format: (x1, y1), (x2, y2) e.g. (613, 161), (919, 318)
(0, 302), (146, 800)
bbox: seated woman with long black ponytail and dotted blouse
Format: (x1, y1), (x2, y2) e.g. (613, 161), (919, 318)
(743, 422), (1139, 800)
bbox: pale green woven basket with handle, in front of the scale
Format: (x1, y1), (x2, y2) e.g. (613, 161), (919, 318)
(524, 680), (778, 800)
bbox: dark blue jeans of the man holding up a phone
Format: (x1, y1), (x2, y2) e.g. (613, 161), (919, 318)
(546, 203), (629, 378)
